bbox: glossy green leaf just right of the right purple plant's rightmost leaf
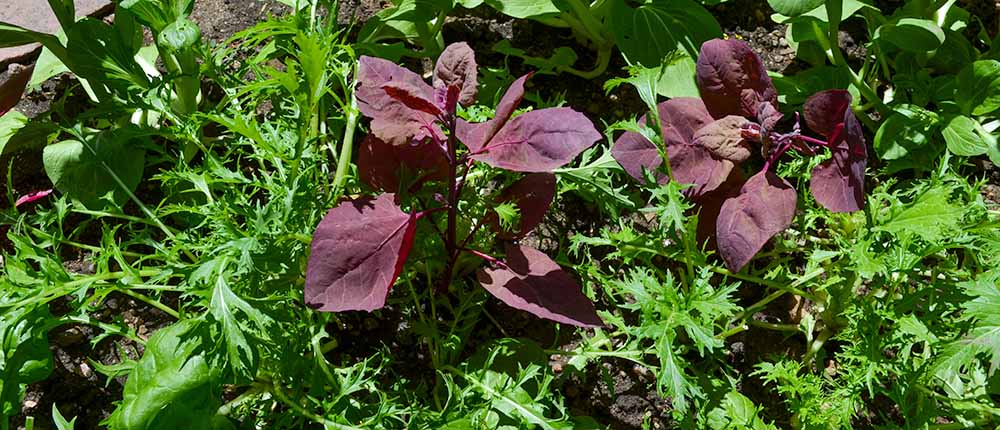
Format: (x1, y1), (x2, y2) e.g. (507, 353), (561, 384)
(874, 105), (943, 173)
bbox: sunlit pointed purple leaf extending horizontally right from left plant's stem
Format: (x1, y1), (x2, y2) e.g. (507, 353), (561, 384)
(470, 108), (601, 172)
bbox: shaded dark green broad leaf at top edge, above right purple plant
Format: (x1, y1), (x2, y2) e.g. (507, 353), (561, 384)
(609, 0), (722, 67)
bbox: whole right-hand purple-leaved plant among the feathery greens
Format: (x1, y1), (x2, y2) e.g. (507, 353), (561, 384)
(612, 39), (868, 271)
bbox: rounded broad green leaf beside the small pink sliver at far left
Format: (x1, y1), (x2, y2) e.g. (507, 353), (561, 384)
(42, 129), (145, 209)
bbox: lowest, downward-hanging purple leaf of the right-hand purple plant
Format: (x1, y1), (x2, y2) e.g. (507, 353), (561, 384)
(716, 171), (796, 272)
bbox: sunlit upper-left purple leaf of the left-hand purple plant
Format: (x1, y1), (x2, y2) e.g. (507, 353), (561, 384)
(354, 56), (444, 145)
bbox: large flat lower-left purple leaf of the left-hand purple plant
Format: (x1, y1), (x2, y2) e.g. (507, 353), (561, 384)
(305, 194), (417, 312)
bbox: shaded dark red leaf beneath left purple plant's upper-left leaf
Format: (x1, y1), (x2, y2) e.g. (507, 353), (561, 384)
(358, 134), (448, 191)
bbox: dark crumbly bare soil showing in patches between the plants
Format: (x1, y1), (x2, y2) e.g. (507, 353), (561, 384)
(7, 0), (1000, 430)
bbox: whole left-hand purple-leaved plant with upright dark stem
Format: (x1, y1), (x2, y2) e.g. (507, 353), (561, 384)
(305, 43), (602, 327)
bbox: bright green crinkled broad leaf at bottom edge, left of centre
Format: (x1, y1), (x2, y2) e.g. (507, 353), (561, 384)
(107, 320), (232, 430)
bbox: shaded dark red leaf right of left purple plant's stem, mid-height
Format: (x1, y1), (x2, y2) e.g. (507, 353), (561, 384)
(486, 173), (556, 240)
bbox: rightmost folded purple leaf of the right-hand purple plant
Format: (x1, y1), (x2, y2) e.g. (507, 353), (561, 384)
(809, 114), (868, 212)
